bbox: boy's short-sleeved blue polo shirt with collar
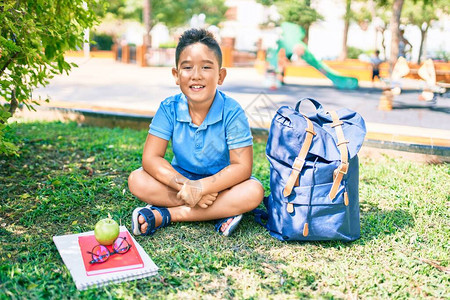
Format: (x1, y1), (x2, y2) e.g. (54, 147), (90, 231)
(149, 91), (253, 175)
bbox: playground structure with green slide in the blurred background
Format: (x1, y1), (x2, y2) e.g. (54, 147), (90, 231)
(266, 22), (358, 89)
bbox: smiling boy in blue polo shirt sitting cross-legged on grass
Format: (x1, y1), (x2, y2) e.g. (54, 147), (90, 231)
(128, 29), (264, 236)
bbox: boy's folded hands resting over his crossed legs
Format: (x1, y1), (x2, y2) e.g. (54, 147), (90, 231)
(177, 180), (218, 208)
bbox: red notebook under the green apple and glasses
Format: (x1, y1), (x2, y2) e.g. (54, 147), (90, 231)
(78, 231), (144, 276)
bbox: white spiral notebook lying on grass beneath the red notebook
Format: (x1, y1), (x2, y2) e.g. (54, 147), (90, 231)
(53, 226), (158, 290)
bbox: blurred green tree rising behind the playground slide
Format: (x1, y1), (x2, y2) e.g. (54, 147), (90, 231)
(258, 0), (323, 44)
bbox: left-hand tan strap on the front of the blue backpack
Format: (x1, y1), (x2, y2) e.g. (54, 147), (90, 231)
(283, 114), (316, 200)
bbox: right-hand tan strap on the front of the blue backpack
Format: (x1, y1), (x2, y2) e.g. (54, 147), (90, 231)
(327, 110), (348, 200)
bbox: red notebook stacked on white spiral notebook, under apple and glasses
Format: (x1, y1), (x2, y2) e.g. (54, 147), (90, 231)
(53, 226), (158, 290)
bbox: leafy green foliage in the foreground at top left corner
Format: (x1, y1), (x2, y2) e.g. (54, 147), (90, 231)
(0, 0), (103, 154)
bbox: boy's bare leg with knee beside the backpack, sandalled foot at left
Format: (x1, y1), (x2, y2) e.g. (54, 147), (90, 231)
(135, 179), (264, 233)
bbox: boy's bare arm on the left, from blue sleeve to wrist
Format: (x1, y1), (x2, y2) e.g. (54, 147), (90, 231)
(142, 134), (187, 191)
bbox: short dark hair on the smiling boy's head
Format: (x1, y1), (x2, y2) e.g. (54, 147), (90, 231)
(175, 28), (222, 68)
